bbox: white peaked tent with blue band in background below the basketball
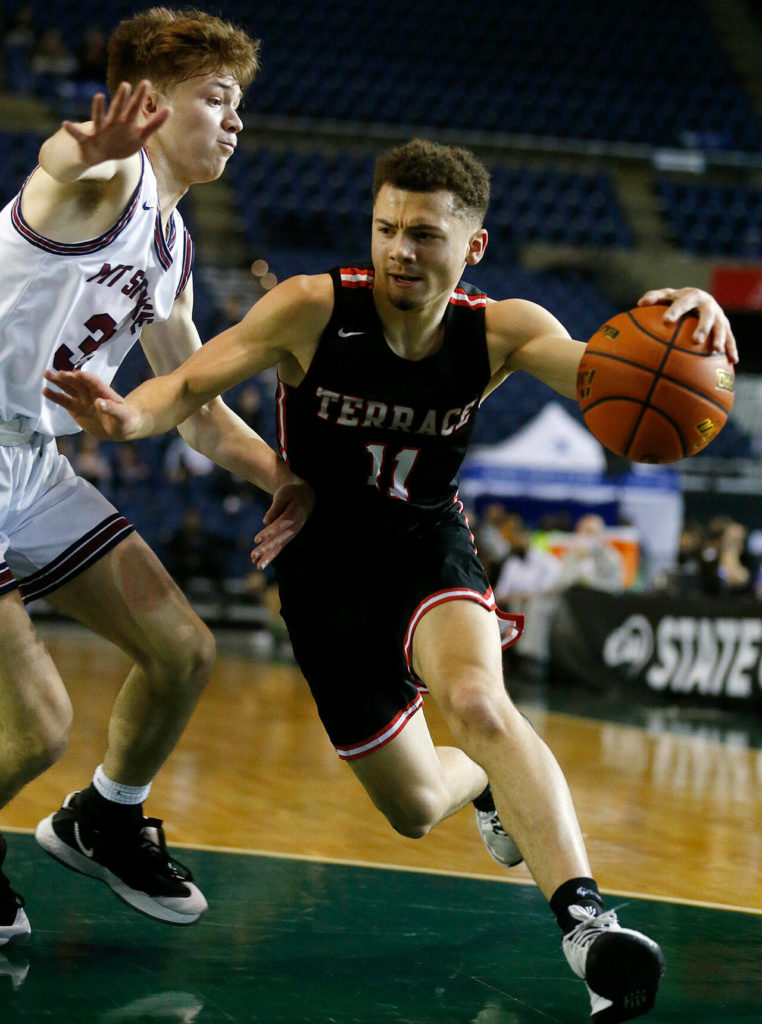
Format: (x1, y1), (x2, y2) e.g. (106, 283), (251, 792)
(460, 401), (683, 578)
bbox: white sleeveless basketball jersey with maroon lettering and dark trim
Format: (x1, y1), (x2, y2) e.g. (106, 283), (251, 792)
(0, 152), (193, 435)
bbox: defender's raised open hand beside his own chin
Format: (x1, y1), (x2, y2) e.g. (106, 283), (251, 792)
(61, 81), (172, 167)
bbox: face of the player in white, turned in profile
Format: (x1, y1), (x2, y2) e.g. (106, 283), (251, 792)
(159, 72), (244, 185)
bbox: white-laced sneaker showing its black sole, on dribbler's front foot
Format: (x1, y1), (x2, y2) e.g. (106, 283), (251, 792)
(561, 906), (664, 1024)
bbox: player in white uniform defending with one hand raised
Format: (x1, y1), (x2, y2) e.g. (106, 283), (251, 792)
(0, 8), (313, 945)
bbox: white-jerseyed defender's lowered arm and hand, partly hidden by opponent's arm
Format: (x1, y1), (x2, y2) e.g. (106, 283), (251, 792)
(140, 281), (314, 568)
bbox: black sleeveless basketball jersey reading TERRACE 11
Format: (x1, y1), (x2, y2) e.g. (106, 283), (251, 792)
(278, 266), (490, 548)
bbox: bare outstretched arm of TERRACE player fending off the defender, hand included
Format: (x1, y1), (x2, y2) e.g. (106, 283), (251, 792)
(43, 273), (333, 440)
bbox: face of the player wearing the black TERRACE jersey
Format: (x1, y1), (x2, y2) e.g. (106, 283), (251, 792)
(372, 184), (486, 309)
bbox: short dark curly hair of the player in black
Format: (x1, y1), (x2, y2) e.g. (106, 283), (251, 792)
(373, 138), (490, 221)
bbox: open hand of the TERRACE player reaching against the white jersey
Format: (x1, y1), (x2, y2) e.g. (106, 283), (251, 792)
(42, 370), (142, 441)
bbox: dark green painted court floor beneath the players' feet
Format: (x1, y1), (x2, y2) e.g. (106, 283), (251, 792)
(0, 834), (762, 1024)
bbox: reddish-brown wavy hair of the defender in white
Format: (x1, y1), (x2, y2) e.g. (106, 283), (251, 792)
(108, 7), (259, 95)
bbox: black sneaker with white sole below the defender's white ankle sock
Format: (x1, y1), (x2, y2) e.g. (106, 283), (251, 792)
(35, 793), (207, 925)
